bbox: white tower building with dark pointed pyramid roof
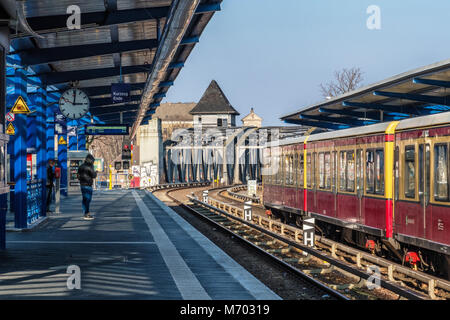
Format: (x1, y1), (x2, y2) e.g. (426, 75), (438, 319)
(190, 80), (239, 128)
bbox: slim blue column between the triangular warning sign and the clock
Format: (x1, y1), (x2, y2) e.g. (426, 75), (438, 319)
(35, 87), (47, 217)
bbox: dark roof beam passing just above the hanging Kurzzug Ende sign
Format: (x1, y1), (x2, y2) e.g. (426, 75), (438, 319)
(36, 64), (151, 85)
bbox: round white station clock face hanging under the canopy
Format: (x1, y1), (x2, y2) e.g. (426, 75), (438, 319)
(59, 88), (90, 119)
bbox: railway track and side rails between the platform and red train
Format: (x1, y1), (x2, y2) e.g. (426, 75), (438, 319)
(149, 186), (450, 300)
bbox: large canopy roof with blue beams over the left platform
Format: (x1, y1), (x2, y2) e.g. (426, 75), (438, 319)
(0, 0), (222, 135)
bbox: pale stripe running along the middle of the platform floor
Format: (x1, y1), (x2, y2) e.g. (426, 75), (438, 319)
(133, 190), (211, 300)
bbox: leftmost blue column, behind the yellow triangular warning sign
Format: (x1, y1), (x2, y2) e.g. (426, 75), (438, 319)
(11, 69), (28, 229)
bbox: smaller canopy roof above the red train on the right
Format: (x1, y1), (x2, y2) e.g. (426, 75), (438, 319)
(280, 59), (450, 130)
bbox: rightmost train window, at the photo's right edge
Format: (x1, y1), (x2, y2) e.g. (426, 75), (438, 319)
(434, 144), (448, 201)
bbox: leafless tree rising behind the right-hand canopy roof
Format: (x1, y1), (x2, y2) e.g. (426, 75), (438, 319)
(320, 67), (363, 98)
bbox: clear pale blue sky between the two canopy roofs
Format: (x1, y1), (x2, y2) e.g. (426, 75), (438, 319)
(164, 0), (450, 125)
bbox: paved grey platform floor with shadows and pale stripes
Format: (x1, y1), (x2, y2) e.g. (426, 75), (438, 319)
(0, 190), (279, 300)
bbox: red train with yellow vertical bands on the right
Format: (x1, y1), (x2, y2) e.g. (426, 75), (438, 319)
(263, 112), (450, 277)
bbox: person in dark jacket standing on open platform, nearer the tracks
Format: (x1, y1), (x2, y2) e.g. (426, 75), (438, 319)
(78, 154), (97, 220)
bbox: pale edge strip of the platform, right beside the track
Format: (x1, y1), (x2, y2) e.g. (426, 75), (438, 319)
(145, 190), (281, 300)
